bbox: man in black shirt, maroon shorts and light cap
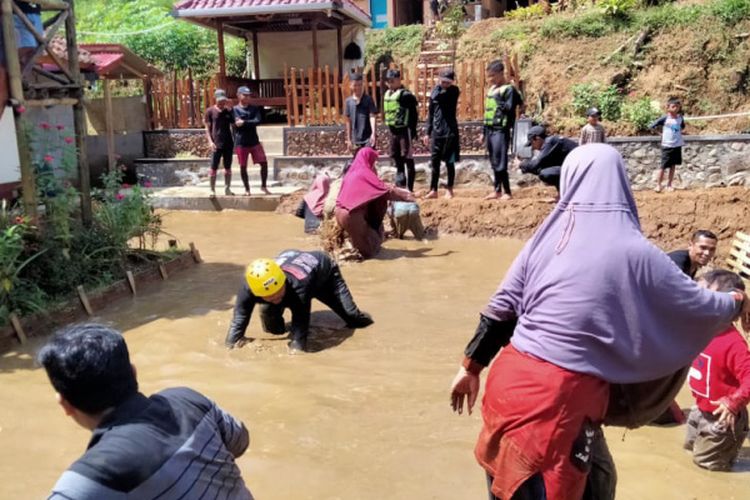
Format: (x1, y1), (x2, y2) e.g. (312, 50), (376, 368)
(232, 87), (271, 196)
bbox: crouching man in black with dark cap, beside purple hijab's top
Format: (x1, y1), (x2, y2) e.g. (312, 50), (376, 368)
(521, 125), (578, 192)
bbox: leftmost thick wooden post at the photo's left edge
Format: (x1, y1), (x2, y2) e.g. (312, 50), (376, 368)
(0, 0), (37, 219)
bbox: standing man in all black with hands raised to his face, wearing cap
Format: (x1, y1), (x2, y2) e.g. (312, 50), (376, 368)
(425, 68), (461, 198)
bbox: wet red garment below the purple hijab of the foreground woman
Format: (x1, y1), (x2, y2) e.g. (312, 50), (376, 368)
(475, 345), (609, 500)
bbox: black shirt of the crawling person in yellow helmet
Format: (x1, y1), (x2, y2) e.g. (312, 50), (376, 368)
(225, 250), (334, 346)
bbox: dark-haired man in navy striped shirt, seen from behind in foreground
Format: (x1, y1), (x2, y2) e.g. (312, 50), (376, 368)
(38, 324), (253, 500)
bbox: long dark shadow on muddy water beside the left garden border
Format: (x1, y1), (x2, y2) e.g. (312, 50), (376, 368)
(0, 262), (244, 373)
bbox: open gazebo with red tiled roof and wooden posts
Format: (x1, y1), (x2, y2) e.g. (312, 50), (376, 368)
(172, 0), (371, 105)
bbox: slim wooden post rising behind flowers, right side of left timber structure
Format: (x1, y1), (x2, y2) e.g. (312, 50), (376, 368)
(65, 0), (91, 225)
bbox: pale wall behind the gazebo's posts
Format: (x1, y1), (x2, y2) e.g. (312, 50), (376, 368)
(258, 26), (365, 79)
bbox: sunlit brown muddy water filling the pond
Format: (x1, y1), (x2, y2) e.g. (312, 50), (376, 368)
(0, 212), (750, 500)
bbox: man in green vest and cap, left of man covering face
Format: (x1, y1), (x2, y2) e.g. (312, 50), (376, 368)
(383, 69), (418, 192)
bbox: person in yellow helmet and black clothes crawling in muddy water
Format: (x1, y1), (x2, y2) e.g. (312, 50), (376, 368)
(224, 250), (373, 352)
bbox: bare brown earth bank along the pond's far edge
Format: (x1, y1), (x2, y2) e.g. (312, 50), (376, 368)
(277, 187), (750, 261)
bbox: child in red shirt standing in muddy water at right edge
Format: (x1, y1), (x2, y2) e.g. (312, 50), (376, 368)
(685, 269), (750, 471)
